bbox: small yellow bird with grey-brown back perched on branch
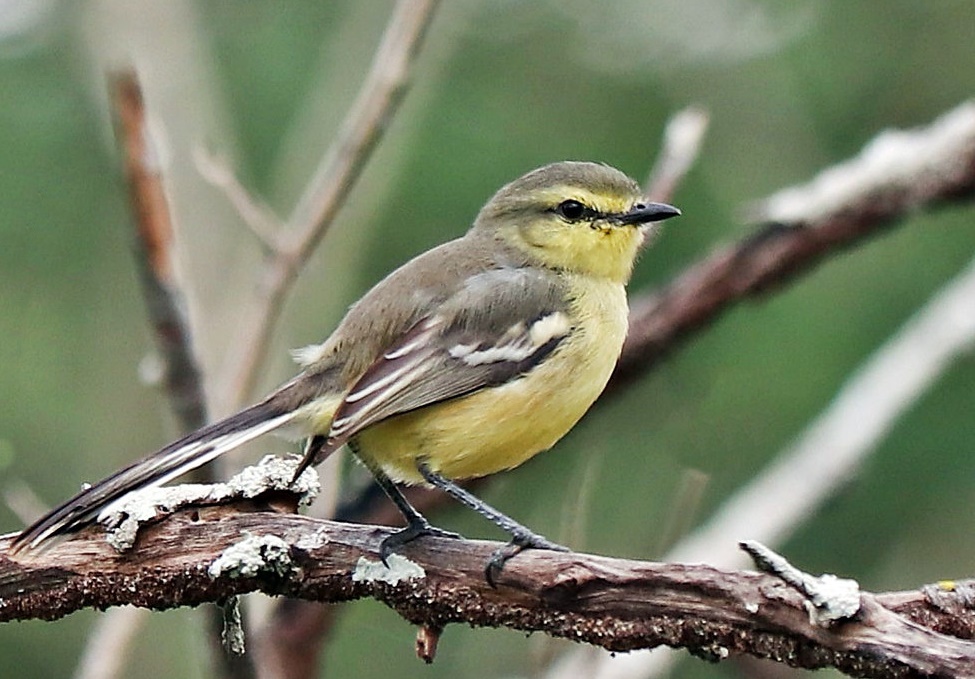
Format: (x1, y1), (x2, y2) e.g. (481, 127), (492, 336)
(12, 162), (680, 569)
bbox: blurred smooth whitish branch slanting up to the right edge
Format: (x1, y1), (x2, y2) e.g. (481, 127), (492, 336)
(672, 250), (975, 566)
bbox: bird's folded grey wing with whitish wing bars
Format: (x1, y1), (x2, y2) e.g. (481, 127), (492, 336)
(328, 269), (573, 449)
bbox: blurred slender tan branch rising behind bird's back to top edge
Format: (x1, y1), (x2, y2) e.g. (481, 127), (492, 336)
(217, 0), (439, 412)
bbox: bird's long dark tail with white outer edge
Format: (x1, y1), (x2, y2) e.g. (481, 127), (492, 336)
(10, 399), (295, 553)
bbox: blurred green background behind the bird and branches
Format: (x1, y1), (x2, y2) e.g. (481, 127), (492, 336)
(0, 0), (975, 679)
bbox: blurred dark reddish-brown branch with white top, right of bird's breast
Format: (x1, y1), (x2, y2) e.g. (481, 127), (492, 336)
(610, 102), (975, 388)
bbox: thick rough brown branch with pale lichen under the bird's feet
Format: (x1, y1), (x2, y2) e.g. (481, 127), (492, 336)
(0, 506), (975, 677)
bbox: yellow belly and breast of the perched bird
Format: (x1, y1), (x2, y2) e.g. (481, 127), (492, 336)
(356, 274), (627, 483)
